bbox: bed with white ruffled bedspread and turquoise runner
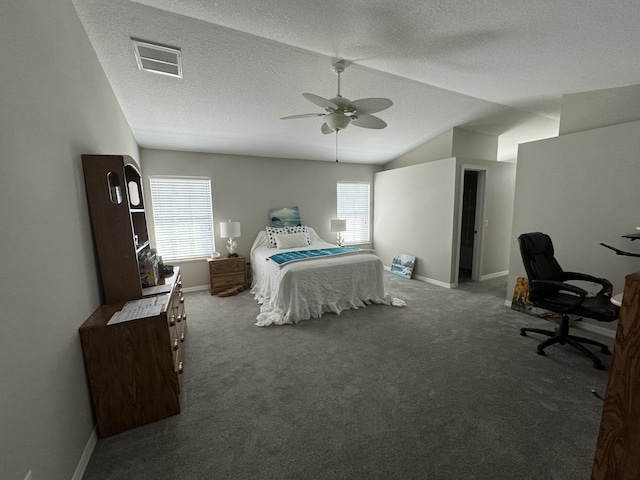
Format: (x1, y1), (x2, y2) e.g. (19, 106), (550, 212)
(251, 227), (405, 327)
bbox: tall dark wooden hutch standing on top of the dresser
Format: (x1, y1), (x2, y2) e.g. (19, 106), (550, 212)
(82, 155), (149, 303)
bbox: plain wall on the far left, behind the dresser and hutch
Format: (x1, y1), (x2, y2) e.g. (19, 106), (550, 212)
(0, 0), (138, 480)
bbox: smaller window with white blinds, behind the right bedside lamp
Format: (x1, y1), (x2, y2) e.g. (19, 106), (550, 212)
(337, 182), (370, 243)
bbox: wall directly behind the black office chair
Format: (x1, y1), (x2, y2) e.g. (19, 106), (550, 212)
(507, 120), (640, 326)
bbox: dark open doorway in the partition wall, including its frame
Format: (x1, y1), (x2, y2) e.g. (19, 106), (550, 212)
(458, 168), (486, 282)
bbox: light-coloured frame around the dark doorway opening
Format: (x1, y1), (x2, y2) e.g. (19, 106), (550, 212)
(454, 165), (488, 287)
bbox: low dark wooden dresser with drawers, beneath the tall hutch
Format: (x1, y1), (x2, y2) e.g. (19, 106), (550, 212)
(80, 268), (187, 438)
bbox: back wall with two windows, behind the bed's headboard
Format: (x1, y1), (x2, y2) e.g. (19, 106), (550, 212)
(141, 149), (380, 288)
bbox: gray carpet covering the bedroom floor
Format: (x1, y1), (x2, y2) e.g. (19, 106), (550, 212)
(84, 272), (613, 480)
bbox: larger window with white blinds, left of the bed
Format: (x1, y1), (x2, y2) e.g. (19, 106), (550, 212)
(150, 177), (215, 261)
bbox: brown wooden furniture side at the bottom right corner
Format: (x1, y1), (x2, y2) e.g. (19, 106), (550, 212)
(591, 273), (640, 480)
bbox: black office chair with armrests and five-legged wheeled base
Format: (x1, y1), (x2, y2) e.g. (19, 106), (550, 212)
(518, 232), (620, 370)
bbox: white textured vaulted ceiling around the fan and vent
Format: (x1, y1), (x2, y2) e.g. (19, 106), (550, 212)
(73, 0), (640, 163)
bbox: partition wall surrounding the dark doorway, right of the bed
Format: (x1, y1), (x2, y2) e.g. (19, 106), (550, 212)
(374, 158), (515, 286)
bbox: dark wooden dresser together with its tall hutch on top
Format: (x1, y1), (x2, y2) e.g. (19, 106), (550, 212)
(80, 155), (187, 437)
